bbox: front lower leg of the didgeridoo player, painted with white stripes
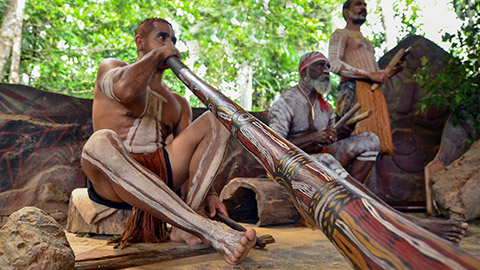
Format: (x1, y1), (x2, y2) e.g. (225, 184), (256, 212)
(82, 129), (242, 257)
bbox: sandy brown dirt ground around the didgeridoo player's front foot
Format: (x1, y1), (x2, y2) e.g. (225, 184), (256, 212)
(67, 213), (480, 270)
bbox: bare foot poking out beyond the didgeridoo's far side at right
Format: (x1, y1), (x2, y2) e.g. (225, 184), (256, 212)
(407, 215), (468, 245)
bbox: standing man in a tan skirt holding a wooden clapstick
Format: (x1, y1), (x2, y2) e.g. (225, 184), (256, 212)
(328, 0), (405, 154)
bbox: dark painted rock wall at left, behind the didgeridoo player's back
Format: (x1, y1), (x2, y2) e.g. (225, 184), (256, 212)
(0, 84), (92, 224)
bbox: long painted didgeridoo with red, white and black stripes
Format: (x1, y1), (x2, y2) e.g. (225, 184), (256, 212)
(166, 57), (480, 270)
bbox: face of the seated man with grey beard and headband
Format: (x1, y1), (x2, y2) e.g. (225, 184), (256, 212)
(305, 60), (330, 95)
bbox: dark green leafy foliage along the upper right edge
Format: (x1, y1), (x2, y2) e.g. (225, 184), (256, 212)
(416, 0), (480, 137)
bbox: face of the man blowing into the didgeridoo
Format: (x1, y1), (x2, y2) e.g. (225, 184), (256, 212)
(145, 22), (177, 52)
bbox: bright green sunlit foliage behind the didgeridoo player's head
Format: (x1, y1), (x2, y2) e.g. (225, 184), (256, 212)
(0, 0), (343, 110)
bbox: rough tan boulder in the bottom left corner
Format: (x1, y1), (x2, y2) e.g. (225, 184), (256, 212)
(0, 207), (75, 270)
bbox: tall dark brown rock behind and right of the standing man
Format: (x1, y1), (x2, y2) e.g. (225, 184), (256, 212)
(366, 36), (449, 205)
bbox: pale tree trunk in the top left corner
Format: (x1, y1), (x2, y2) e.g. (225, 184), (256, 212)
(0, 0), (25, 83)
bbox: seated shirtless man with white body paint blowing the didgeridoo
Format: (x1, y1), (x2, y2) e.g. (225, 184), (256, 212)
(82, 18), (256, 264)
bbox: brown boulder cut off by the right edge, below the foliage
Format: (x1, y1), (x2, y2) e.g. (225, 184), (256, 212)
(431, 141), (480, 221)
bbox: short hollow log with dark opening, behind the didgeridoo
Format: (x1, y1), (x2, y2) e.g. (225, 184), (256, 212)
(220, 178), (301, 227)
